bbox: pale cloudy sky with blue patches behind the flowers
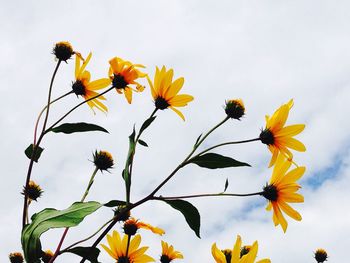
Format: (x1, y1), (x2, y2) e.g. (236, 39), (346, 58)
(0, 0), (350, 263)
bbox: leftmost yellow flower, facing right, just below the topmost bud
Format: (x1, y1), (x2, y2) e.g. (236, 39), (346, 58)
(72, 52), (111, 112)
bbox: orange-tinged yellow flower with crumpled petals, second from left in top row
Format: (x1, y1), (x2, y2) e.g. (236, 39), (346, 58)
(109, 57), (147, 104)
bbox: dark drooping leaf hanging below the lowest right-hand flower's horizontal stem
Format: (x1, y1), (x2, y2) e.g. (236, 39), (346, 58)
(163, 200), (201, 238)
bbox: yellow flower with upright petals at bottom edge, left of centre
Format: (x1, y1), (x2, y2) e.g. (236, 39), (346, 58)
(101, 231), (155, 263)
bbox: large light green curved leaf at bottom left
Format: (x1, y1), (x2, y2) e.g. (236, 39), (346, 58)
(21, 202), (102, 263)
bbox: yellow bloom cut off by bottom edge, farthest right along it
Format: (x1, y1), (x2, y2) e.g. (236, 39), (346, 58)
(211, 235), (271, 263)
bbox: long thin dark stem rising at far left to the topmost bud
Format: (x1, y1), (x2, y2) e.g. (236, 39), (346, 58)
(22, 60), (61, 228)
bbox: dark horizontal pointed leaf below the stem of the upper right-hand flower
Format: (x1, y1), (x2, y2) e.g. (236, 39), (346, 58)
(189, 153), (250, 169)
